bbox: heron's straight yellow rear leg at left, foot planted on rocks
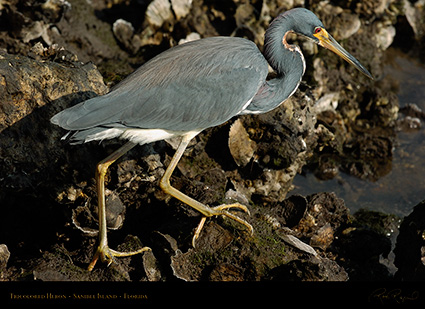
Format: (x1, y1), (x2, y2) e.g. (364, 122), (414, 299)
(88, 142), (150, 271)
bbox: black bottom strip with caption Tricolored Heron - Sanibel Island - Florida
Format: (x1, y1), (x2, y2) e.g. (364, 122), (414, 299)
(0, 281), (425, 307)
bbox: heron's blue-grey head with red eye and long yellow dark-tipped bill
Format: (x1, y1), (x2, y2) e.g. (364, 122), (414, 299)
(284, 8), (373, 79)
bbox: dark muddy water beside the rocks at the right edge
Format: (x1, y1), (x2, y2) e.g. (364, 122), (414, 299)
(290, 48), (425, 217)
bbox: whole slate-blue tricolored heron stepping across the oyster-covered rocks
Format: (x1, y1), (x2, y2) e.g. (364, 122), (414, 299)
(51, 8), (372, 270)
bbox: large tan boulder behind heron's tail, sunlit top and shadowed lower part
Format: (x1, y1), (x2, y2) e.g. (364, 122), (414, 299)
(0, 47), (107, 188)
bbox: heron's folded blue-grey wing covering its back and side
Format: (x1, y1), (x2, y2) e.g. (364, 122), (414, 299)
(52, 37), (267, 131)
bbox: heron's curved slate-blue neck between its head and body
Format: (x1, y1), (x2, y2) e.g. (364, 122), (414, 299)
(246, 20), (305, 113)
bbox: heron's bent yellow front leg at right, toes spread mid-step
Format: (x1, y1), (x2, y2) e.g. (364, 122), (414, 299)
(160, 135), (254, 247)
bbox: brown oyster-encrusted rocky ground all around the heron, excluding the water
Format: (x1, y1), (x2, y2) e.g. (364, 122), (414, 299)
(0, 0), (425, 281)
